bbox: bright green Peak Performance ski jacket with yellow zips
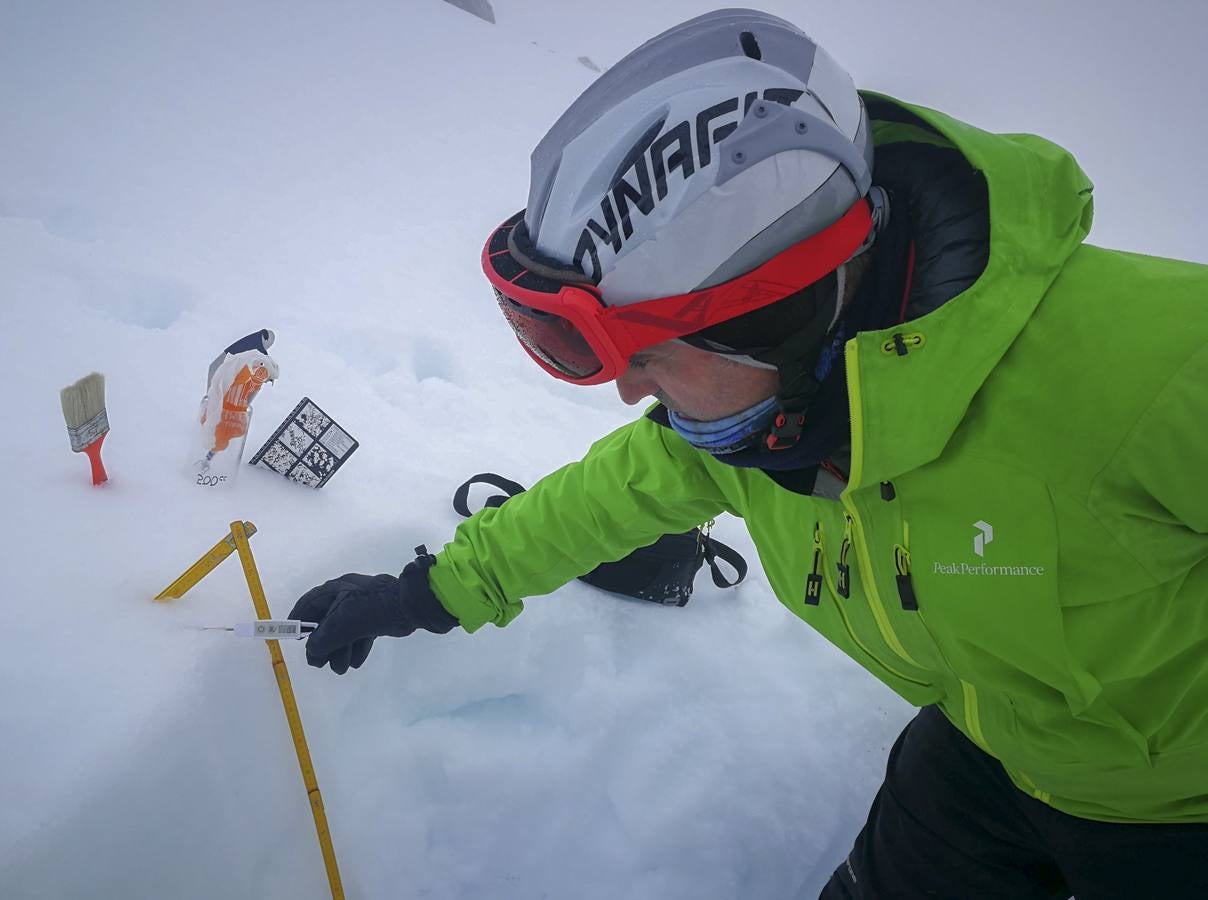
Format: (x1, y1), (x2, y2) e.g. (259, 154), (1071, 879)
(430, 97), (1208, 823)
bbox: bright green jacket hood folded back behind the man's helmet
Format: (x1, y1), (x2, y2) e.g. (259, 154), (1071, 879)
(846, 94), (1092, 488)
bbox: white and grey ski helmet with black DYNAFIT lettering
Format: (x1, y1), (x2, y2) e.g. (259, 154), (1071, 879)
(516, 10), (872, 306)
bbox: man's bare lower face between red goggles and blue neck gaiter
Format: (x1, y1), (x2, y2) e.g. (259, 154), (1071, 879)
(616, 341), (779, 422)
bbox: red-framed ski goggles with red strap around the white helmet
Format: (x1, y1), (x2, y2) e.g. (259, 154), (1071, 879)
(482, 198), (872, 384)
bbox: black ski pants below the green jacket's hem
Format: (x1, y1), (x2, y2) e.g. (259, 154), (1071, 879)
(820, 707), (1208, 900)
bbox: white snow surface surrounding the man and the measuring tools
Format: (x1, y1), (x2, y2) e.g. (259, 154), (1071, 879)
(0, 0), (1208, 900)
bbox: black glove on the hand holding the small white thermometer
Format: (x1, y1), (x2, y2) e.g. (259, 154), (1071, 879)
(290, 545), (458, 675)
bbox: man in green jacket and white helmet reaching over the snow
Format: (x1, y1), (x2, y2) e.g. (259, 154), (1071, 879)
(292, 10), (1208, 899)
